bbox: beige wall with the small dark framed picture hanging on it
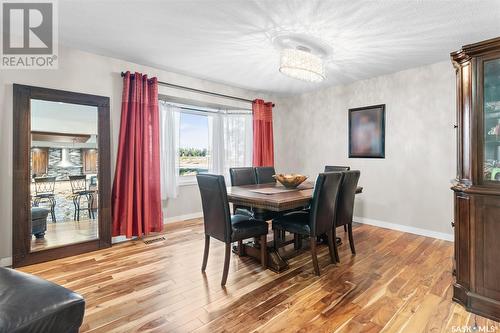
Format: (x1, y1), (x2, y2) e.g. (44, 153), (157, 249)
(274, 62), (455, 239)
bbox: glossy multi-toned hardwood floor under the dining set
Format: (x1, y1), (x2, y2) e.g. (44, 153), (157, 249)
(22, 219), (500, 333)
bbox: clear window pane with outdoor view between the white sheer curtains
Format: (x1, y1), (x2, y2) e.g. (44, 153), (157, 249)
(179, 112), (209, 177)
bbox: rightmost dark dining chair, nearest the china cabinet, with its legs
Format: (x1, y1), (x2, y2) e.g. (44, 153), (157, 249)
(333, 170), (361, 262)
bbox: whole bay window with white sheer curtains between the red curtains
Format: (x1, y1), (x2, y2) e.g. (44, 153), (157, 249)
(160, 100), (253, 199)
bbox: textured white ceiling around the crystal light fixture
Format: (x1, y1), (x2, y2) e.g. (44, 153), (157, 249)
(59, 0), (500, 94)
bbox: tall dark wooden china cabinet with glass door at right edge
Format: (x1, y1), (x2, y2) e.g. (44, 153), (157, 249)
(451, 38), (500, 321)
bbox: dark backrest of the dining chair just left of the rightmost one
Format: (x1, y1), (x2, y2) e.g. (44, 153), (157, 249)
(309, 172), (343, 237)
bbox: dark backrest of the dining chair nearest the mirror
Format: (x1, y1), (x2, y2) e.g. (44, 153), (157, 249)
(196, 174), (232, 243)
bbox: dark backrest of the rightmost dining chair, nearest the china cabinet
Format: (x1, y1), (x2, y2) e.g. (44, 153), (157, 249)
(335, 170), (361, 226)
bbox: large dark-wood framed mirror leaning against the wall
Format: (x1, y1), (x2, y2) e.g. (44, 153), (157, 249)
(12, 84), (111, 267)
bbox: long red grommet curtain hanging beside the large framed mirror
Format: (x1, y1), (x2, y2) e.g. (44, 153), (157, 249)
(112, 72), (163, 238)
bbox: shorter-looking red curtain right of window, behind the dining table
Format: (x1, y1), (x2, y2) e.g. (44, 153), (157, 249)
(252, 99), (274, 166)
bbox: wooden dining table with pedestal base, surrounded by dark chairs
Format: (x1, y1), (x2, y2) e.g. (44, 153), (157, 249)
(227, 181), (363, 272)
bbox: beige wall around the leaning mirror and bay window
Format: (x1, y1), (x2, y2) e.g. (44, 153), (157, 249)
(0, 48), (260, 264)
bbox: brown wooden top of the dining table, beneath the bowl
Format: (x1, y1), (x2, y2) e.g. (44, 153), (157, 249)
(227, 181), (363, 212)
